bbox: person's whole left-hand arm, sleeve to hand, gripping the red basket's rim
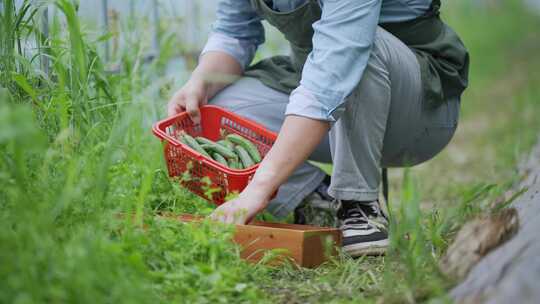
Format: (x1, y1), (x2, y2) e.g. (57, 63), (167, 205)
(167, 0), (264, 124)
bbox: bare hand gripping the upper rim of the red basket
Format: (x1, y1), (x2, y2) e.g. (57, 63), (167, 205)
(167, 77), (208, 124)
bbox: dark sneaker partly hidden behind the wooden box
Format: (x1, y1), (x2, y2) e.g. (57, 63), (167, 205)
(294, 176), (338, 227)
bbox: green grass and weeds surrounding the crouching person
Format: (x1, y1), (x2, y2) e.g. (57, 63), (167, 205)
(0, 0), (540, 303)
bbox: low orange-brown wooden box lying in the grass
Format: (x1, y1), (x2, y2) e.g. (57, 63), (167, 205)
(171, 214), (341, 268)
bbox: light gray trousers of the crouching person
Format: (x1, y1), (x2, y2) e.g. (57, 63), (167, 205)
(210, 28), (460, 217)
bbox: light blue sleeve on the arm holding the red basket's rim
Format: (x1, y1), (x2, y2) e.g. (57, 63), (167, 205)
(201, 0), (265, 69)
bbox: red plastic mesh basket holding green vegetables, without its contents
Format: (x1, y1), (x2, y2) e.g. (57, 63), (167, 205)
(152, 105), (277, 205)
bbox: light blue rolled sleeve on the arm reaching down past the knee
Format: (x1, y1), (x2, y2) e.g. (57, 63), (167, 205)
(285, 0), (382, 121)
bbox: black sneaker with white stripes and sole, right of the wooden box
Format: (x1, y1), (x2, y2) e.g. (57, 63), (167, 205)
(338, 201), (388, 257)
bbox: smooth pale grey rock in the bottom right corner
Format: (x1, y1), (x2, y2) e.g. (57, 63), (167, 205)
(446, 141), (540, 304)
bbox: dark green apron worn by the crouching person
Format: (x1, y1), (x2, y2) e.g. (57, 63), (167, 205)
(245, 0), (469, 107)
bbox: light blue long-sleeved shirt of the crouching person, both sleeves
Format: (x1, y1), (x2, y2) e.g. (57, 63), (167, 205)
(202, 0), (431, 121)
